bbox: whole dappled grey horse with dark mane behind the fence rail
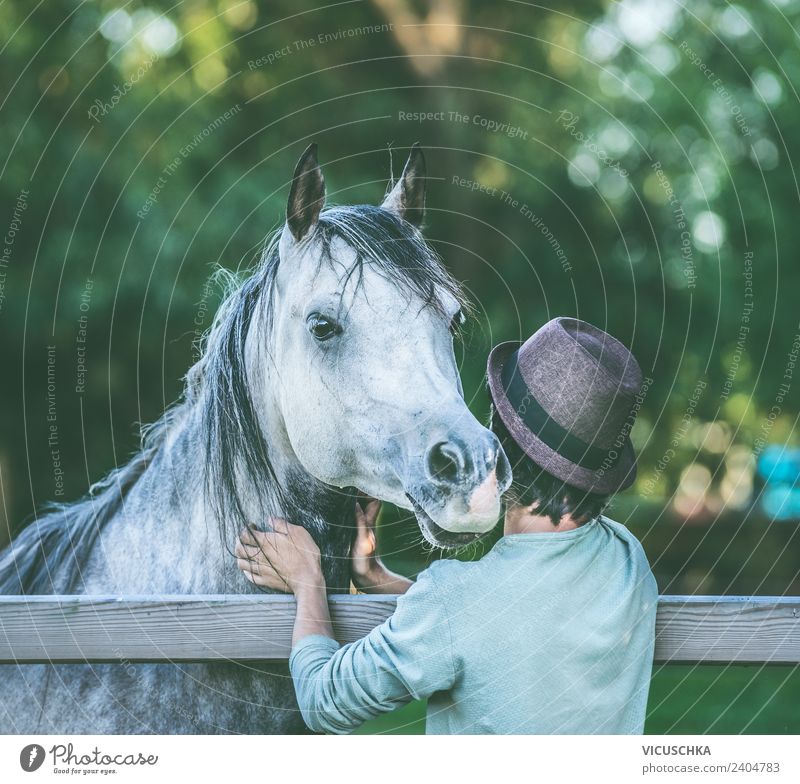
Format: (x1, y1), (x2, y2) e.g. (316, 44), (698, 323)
(0, 146), (510, 734)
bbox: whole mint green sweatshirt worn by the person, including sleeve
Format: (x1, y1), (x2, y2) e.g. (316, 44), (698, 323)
(289, 517), (658, 734)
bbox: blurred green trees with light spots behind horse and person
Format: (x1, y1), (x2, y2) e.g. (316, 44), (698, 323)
(0, 0), (800, 731)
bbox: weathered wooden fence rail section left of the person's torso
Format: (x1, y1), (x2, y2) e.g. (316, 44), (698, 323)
(0, 595), (395, 663)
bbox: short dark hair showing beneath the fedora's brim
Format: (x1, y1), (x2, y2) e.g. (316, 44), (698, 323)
(489, 397), (610, 525)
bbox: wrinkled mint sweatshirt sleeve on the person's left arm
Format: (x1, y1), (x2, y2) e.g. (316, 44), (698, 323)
(289, 570), (456, 733)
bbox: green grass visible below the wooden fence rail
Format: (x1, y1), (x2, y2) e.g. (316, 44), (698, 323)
(357, 665), (800, 735)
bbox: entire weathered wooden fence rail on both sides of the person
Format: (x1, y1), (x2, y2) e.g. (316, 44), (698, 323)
(0, 595), (800, 664)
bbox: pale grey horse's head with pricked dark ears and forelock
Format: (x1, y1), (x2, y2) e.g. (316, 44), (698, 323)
(260, 145), (511, 547)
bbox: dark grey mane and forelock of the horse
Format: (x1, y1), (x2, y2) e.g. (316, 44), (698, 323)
(0, 205), (469, 594)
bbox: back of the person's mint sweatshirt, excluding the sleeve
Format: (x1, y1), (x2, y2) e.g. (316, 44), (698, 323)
(427, 517), (658, 734)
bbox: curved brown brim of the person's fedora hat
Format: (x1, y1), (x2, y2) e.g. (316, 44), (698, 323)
(487, 340), (636, 495)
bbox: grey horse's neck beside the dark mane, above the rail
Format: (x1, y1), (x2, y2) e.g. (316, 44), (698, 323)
(99, 306), (355, 592)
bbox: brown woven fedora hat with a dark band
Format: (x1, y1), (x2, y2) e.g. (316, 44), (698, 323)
(488, 317), (642, 495)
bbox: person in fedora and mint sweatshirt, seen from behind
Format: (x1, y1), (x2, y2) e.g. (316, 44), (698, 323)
(237, 318), (658, 734)
